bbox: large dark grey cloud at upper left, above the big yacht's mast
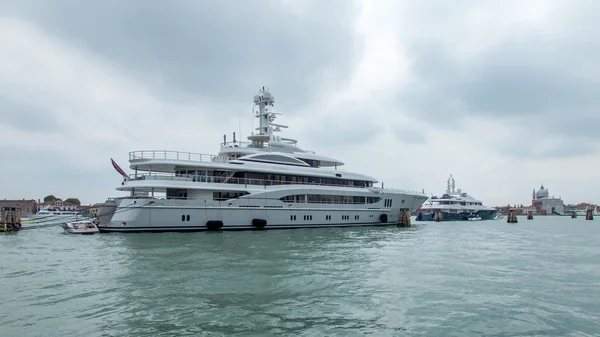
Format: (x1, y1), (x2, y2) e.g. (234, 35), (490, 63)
(0, 0), (359, 113)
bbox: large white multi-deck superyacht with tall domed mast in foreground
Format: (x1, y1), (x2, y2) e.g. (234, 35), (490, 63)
(98, 87), (427, 232)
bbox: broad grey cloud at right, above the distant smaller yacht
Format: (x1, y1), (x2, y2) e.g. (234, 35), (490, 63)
(401, 37), (600, 119)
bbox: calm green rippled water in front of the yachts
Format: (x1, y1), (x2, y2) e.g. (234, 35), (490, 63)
(0, 217), (600, 336)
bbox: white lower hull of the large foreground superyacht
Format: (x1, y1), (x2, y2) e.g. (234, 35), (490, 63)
(98, 190), (426, 232)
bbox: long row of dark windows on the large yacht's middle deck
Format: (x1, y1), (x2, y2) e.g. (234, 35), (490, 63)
(135, 170), (373, 187)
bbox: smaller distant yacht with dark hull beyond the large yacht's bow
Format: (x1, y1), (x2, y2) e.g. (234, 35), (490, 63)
(416, 175), (498, 221)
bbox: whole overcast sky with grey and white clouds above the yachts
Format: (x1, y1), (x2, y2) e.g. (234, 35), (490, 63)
(0, 0), (600, 206)
